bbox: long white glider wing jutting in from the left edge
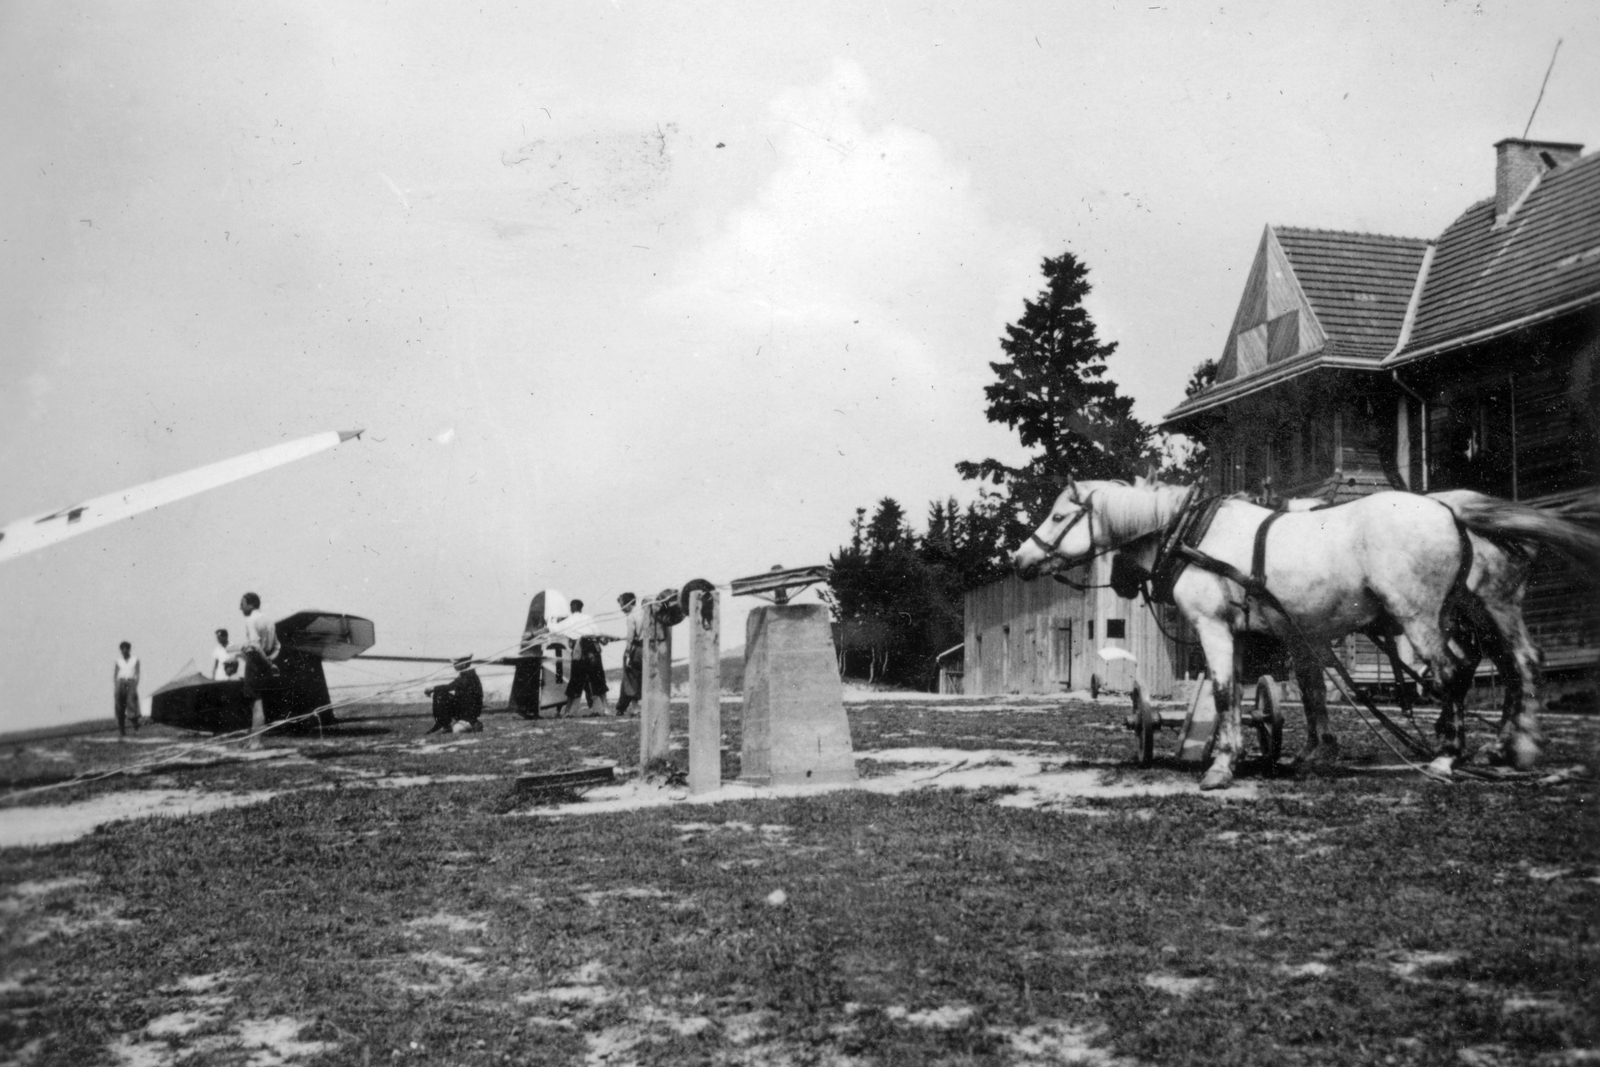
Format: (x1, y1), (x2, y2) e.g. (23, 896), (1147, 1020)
(0, 430), (362, 563)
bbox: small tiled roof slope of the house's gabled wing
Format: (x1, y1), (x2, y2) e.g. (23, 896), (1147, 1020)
(1274, 226), (1427, 360)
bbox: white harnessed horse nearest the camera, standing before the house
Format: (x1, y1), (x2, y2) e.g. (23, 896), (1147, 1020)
(1011, 482), (1600, 789)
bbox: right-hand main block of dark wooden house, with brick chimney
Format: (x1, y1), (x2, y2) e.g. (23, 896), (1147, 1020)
(1384, 138), (1600, 675)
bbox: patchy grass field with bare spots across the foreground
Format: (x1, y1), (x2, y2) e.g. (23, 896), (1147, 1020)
(0, 699), (1600, 1065)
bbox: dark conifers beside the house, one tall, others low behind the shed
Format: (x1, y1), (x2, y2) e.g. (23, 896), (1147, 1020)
(829, 251), (1216, 688)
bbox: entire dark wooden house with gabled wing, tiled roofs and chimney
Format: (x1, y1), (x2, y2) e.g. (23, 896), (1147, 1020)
(1162, 139), (1600, 680)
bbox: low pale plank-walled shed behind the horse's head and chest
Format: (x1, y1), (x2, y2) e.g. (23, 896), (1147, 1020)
(963, 557), (1179, 697)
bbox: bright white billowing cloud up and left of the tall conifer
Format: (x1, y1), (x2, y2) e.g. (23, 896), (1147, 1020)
(651, 61), (1040, 451)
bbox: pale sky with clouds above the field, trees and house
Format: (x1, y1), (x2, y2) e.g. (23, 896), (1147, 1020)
(0, 0), (1600, 733)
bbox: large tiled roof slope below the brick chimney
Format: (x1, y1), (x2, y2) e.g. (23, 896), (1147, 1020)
(1389, 152), (1600, 363)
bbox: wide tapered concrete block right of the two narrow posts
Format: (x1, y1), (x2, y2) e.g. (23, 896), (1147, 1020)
(741, 605), (856, 785)
